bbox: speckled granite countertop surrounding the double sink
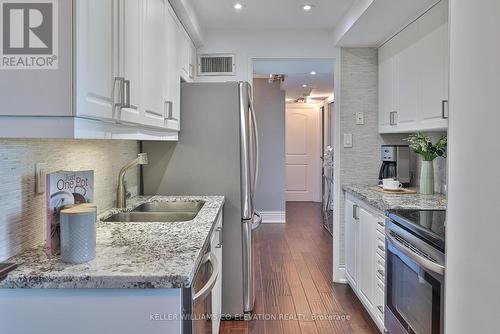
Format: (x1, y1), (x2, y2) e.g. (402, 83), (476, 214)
(0, 196), (224, 289)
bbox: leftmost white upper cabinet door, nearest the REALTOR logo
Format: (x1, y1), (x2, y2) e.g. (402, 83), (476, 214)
(75, 0), (118, 120)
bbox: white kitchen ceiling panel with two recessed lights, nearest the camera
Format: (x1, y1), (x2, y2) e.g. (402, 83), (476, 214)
(190, 0), (354, 31)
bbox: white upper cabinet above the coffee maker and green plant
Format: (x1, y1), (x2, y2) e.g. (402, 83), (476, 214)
(379, 1), (449, 133)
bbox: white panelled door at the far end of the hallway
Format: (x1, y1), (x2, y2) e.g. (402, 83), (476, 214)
(285, 105), (321, 202)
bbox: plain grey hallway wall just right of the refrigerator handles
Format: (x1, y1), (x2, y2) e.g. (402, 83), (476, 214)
(253, 79), (285, 214)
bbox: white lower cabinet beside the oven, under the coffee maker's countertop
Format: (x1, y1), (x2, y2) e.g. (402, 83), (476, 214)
(345, 195), (385, 332)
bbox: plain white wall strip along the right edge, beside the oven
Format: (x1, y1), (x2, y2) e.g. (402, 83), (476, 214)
(445, 0), (500, 334)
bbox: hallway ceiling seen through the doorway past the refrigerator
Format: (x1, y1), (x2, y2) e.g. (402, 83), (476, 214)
(253, 59), (335, 100)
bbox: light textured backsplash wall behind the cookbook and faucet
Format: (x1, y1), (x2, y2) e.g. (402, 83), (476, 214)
(0, 139), (138, 261)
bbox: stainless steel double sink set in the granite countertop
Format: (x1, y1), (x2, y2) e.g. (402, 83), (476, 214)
(104, 201), (205, 223)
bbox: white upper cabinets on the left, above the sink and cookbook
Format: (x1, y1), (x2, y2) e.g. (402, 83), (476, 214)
(0, 0), (194, 140)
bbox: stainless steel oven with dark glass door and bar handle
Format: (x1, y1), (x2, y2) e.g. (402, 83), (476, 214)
(384, 214), (445, 334)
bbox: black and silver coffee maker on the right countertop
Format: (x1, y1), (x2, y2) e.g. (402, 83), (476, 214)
(378, 145), (410, 187)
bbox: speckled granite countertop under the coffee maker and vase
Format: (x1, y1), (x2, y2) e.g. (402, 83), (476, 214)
(343, 184), (446, 212)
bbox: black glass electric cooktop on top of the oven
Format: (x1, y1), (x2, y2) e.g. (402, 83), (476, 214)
(387, 210), (446, 251)
